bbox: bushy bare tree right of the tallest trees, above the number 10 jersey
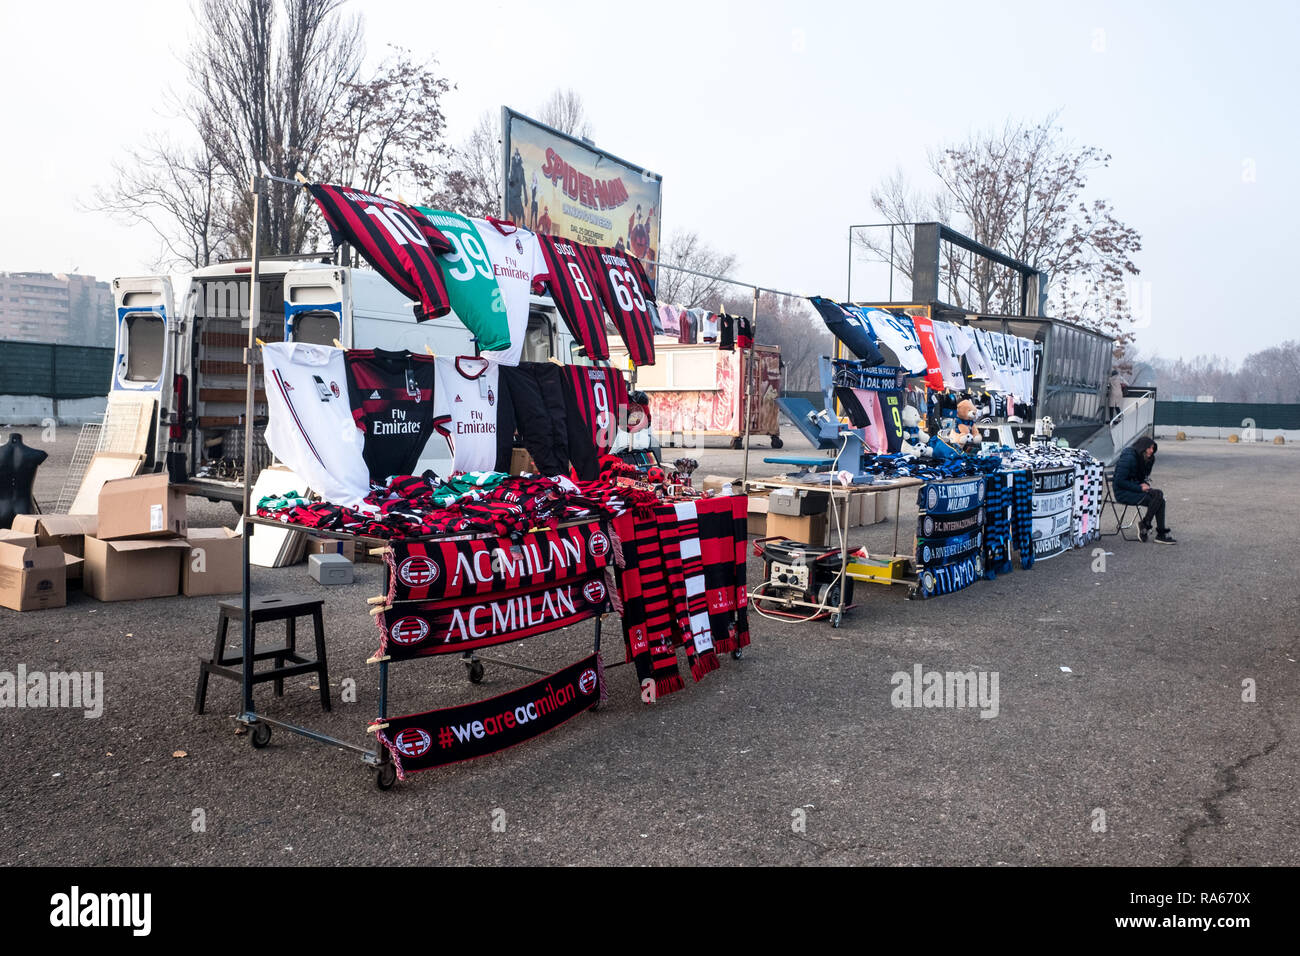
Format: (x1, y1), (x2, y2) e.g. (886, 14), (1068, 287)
(313, 47), (452, 199)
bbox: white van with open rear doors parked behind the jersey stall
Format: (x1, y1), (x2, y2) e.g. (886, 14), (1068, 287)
(105, 254), (573, 502)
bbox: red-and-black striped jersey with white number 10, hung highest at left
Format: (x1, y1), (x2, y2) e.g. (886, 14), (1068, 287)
(307, 183), (452, 321)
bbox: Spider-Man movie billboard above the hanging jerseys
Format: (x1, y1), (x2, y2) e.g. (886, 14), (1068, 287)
(501, 107), (663, 278)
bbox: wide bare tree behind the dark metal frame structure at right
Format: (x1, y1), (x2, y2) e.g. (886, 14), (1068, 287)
(855, 113), (1141, 346)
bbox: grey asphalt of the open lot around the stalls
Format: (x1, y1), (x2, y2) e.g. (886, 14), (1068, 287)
(0, 429), (1300, 866)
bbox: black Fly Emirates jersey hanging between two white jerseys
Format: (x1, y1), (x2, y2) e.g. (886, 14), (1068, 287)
(345, 349), (434, 484)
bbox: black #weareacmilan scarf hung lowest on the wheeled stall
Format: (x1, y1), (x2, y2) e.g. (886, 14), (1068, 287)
(371, 654), (605, 780)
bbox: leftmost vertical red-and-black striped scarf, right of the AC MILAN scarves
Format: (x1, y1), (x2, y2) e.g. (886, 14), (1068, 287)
(610, 511), (684, 697)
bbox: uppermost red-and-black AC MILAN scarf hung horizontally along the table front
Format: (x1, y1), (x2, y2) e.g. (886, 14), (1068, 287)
(384, 522), (610, 604)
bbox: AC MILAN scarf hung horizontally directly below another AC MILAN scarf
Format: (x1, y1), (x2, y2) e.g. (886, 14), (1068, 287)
(376, 571), (611, 661)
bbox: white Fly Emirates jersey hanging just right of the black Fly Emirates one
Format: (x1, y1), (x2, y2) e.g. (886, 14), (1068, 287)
(433, 355), (501, 473)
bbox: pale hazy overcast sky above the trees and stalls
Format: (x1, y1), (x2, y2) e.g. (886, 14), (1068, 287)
(0, 0), (1300, 362)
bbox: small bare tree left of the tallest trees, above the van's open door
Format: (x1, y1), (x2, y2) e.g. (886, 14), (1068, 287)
(90, 130), (231, 269)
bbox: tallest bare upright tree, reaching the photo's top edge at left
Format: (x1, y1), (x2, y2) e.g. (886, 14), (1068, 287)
(189, 0), (363, 254)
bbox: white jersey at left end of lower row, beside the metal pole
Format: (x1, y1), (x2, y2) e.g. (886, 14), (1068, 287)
(261, 342), (371, 507)
